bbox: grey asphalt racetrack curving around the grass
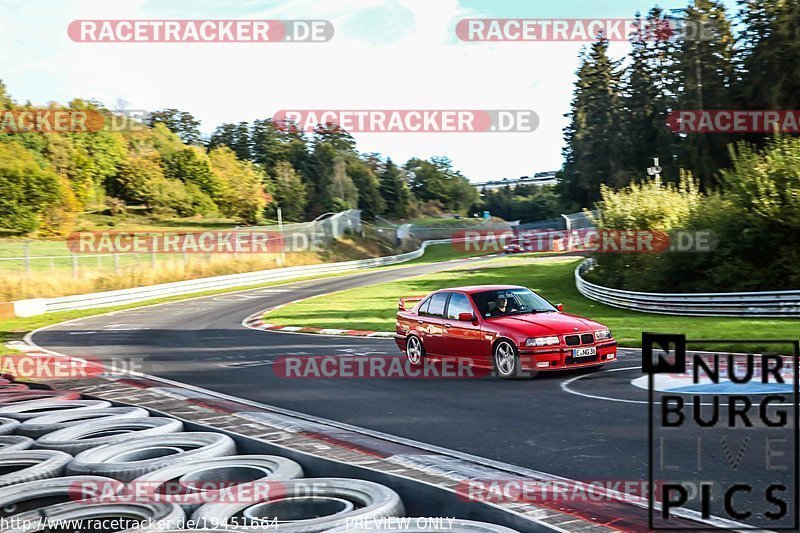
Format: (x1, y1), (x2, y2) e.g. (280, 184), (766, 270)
(33, 259), (795, 517)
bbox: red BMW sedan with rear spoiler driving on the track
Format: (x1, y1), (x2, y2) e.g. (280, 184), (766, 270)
(395, 285), (617, 378)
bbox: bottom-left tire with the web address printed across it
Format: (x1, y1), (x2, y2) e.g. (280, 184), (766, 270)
(0, 502), (186, 533)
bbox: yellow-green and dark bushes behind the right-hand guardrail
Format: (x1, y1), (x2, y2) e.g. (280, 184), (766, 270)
(590, 137), (800, 292)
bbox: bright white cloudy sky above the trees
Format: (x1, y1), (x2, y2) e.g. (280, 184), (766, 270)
(0, 0), (734, 182)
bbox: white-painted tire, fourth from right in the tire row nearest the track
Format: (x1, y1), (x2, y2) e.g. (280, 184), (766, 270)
(67, 432), (236, 481)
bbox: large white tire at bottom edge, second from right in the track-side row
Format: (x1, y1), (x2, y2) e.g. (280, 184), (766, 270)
(192, 478), (405, 533)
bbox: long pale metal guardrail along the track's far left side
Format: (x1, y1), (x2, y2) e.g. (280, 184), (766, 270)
(14, 239), (451, 316)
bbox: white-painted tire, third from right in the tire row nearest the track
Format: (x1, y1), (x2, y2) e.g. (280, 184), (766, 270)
(131, 455), (303, 513)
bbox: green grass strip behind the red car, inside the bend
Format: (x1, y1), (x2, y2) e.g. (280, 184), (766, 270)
(266, 257), (800, 351)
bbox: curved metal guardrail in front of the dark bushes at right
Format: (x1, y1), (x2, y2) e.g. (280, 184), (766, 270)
(575, 259), (800, 318)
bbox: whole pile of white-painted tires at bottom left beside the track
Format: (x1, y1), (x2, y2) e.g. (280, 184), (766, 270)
(0, 382), (512, 533)
